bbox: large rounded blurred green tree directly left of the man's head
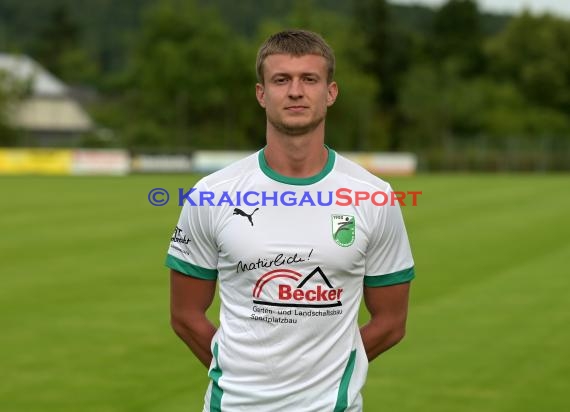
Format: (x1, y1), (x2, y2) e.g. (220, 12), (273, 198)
(128, 0), (255, 148)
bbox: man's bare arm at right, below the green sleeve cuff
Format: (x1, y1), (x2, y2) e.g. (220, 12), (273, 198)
(360, 282), (410, 361)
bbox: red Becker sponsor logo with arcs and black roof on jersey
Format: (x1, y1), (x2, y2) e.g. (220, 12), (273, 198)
(251, 266), (344, 323)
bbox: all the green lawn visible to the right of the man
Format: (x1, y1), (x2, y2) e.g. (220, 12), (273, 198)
(365, 176), (570, 412)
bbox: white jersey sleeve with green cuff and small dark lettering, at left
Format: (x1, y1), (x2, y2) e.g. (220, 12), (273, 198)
(166, 181), (218, 280)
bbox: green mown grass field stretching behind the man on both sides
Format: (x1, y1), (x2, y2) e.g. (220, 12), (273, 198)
(0, 175), (570, 412)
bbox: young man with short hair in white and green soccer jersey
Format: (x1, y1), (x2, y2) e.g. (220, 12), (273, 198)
(167, 30), (414, 412)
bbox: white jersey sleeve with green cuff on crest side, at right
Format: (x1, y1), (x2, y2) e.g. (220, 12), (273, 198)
(364, 188), (415, 287)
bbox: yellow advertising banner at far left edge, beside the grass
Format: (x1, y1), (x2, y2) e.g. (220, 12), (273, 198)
(0, 149), (72, 175)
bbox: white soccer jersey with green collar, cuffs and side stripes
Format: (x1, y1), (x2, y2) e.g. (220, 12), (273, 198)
(167, 149), (414, 412)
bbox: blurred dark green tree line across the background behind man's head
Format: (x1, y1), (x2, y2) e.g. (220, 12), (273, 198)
(0, 0), (570, 156)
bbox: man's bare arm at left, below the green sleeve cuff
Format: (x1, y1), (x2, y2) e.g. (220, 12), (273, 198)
(170, 269), (216, 367)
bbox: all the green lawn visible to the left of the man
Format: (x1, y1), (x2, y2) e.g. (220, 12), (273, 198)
(0, 178), (202, 411)
